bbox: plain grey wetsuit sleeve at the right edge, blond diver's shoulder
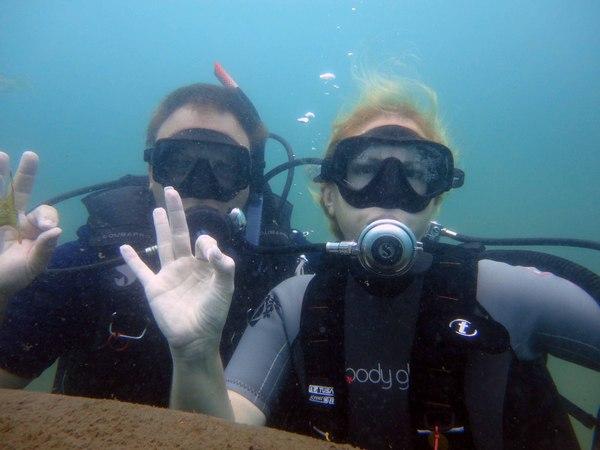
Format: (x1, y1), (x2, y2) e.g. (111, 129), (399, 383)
(477, 260), (600, 370)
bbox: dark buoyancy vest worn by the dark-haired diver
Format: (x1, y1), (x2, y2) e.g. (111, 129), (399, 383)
(54, 181), (303, 406)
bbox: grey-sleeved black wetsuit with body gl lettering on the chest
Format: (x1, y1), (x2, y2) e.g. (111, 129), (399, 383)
(226, 260), (600, 448)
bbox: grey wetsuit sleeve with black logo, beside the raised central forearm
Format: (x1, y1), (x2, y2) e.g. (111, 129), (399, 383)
(225, 275), (312, 417)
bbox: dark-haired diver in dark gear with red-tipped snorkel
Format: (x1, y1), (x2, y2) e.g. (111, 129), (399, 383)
(0, 65), (304, 406)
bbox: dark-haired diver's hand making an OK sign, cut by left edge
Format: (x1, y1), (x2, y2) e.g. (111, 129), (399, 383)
(0, 151), (62, 298)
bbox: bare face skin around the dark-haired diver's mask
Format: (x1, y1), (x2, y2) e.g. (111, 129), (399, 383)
(149, 106), (250, 213)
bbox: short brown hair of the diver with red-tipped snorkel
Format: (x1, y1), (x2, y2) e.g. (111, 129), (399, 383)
(146, 83), (268, 150)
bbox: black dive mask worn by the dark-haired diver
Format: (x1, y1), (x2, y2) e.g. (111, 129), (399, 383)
(144, 128), (251, 202)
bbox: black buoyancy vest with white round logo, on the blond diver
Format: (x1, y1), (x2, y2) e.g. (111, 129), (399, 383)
(292, 243), (579, 450)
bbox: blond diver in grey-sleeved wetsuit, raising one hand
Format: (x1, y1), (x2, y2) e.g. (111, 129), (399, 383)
(121, 76), (600, 450)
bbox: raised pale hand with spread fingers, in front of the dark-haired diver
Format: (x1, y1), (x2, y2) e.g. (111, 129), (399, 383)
(121, 187), (235, 358)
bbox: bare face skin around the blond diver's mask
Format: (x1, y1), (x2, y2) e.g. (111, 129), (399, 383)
(323, 115), (439, 240)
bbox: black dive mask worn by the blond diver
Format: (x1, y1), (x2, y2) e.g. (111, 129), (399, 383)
(315, 125), (464, 213)
